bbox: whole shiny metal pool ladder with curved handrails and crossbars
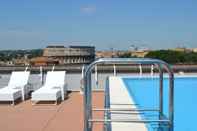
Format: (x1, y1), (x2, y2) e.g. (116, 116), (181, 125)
(83, 58), (174, 131)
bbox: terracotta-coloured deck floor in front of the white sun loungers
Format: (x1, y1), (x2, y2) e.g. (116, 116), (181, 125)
(0, 92), (104, 131)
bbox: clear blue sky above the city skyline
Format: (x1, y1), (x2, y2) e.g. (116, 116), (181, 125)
(0, 0), (197, 50)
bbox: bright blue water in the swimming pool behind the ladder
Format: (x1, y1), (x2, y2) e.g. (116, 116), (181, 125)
(123, 77), (197, 131)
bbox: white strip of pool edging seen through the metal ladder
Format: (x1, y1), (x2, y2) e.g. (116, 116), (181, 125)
(109, 76), (148, 131)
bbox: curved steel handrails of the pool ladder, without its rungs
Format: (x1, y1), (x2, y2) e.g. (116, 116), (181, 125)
(84, 58), (174, 131)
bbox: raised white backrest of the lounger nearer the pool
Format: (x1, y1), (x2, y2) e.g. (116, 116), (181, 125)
(45, 71), (66, 86)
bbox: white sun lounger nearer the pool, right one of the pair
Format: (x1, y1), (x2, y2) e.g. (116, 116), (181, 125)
(31, 71), (66, 104)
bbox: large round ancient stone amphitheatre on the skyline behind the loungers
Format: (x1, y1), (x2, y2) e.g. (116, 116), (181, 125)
(43, 46), (95, 64)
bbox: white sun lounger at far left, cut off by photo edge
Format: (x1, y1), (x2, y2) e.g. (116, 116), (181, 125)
(0, 71), (30, 105)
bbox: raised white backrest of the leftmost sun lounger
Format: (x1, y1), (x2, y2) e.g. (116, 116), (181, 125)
(8, 71), (30, 87)
